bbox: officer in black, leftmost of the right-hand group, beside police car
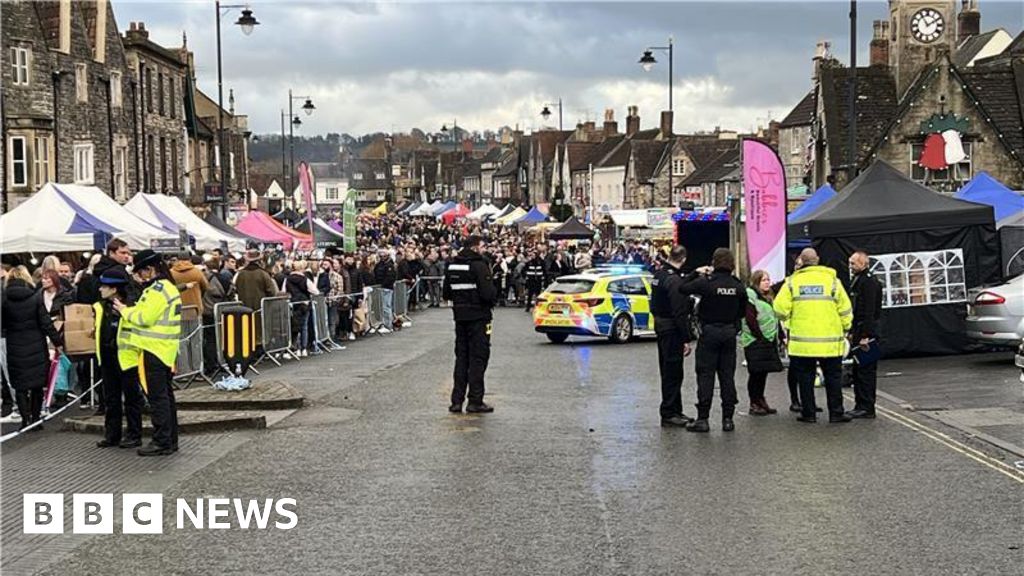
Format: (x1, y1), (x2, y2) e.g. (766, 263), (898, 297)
(650, 246), (693, 427)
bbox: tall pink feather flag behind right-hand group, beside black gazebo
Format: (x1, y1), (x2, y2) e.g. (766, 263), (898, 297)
(742, 138), (785, 280)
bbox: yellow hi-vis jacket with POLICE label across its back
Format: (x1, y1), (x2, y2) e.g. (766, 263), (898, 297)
(773, 265), (853, 358)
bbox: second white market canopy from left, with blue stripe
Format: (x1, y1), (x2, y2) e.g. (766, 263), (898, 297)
(125, 194), (246, 252)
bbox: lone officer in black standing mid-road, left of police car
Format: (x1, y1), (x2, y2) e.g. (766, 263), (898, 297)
(441, 236), (498, 413)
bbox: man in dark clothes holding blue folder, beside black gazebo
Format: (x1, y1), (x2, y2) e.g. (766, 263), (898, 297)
(847, 250), (882, 418)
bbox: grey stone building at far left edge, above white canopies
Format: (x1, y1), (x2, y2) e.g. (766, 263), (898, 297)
(2, 0), (137, 209)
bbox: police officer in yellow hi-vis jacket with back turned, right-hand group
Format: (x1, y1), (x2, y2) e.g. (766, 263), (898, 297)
(774, 248), (853, 423)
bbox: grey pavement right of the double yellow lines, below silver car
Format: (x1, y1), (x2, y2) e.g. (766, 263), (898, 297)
(879, 353), (1024, 458)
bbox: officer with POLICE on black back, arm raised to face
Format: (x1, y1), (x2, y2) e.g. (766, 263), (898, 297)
(680, 248), (746, 433)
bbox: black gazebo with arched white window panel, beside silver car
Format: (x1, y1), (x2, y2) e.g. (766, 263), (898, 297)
(788, 161), (1000, 357)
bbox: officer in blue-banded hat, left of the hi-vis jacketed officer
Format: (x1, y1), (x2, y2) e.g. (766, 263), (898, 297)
(92, 264), (142, 448)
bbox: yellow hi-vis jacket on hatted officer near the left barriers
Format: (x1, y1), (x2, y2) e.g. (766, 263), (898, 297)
(118, 280), (181, 368)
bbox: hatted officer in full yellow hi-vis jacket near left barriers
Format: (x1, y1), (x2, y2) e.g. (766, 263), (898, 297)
(115, 250), (181, 456)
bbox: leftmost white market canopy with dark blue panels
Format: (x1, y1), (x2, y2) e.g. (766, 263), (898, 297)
(0, 182), (176, 254)
